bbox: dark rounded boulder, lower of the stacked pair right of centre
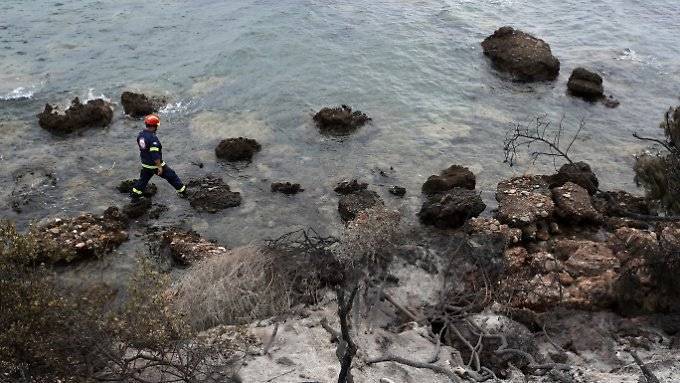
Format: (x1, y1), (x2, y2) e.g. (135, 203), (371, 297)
(418, 188), (486, 228)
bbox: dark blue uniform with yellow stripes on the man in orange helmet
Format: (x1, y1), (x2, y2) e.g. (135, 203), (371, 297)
(132, 129), (186, 196)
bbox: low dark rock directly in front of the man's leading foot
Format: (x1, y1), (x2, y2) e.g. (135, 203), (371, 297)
(187, 176), (241, 213)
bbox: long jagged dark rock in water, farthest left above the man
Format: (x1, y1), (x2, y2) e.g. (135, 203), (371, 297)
(38, 97), (113, 134)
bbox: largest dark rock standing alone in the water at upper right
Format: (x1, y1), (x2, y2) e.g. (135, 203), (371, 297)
(482, 26), (560, 81)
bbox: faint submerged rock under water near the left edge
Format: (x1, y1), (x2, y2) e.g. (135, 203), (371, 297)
(9, 167), (57, 213)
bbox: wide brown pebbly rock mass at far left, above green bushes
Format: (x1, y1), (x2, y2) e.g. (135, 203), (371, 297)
(38, 207), (128, 263)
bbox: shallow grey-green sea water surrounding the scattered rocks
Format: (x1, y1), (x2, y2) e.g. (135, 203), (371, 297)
(0, 0), (680, 246)
